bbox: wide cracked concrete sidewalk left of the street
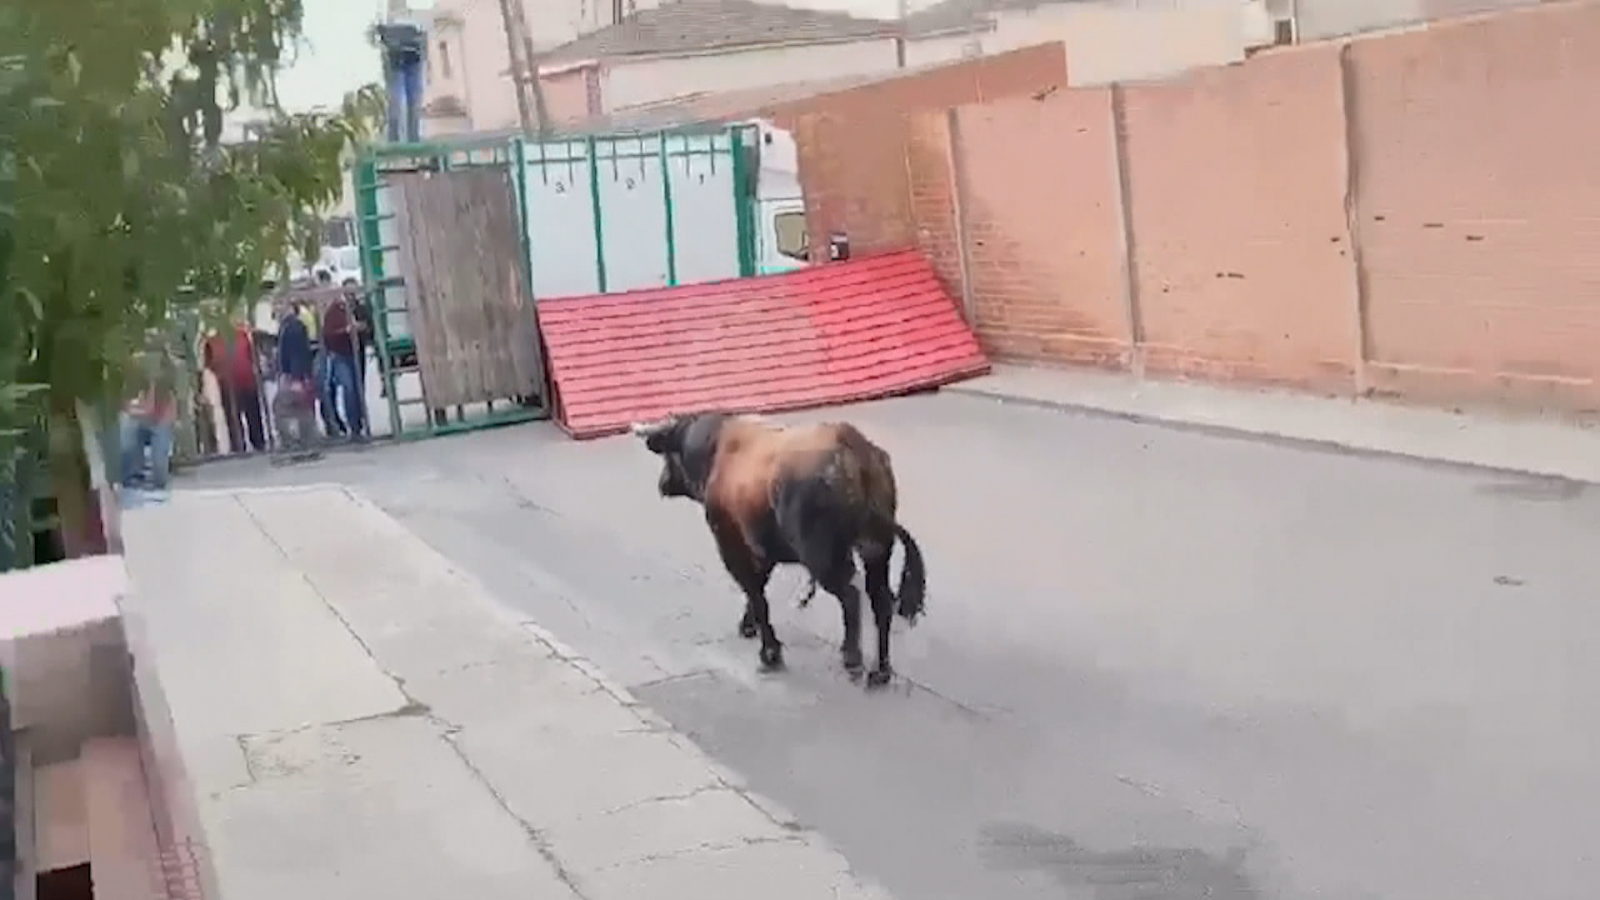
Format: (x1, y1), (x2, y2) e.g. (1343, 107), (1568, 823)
(125, 487), (888, 900)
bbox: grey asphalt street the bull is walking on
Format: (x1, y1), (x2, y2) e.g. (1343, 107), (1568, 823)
(179, 394), (1600, 900)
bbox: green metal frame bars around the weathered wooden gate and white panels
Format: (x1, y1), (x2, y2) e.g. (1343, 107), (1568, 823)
(355, 125), (760, 439)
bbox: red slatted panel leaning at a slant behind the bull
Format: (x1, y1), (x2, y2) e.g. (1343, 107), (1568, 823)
(539, 250), (989, 437)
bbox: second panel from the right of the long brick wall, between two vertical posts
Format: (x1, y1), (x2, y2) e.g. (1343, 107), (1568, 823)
(1123, 45), (1358, 389)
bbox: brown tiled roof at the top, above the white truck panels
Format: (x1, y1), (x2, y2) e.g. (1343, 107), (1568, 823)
(539, 0), (901, 64)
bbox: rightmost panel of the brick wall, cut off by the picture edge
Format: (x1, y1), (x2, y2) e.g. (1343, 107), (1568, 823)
(1350, 5), (1600, 410)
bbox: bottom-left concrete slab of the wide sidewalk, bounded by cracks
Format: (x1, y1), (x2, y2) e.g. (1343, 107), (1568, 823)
(206, 717), (578, 900)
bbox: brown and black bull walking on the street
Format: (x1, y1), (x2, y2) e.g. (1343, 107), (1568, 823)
(634, 413), (926, 687)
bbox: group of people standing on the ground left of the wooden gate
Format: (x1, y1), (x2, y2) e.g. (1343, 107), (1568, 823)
(120, 286), (373, 493)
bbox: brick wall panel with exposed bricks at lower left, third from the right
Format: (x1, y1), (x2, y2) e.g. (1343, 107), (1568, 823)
(957, 88), (1131, 365)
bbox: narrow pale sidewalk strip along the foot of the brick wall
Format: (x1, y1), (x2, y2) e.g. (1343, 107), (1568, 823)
(944, 365), (1600, 484)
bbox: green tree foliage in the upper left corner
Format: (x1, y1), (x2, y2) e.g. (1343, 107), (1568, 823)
(0, 0), (382, 563)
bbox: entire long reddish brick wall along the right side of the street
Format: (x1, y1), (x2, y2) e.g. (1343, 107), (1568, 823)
(864, 2), (1600, 412)
